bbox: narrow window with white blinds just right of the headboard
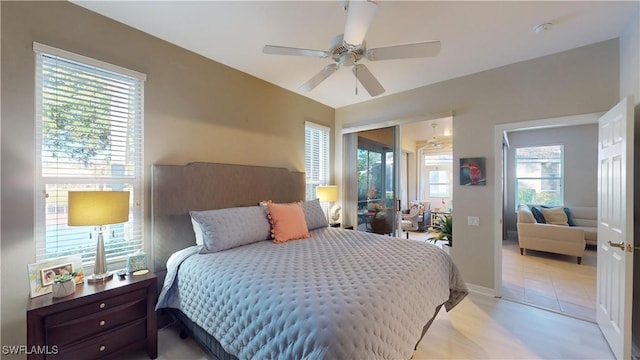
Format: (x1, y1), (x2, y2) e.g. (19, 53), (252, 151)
(304, 121), (330, 200)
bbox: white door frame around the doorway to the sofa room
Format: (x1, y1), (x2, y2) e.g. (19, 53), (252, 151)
(493, 112), (604, 297)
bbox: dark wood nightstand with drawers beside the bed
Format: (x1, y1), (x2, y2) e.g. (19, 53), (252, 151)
(27, 272), (158, 359)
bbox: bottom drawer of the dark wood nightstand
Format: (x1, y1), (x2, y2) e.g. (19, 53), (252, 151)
(47, 320), (146, 359)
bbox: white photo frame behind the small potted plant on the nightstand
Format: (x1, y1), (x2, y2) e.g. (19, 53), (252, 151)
(27, 255), (84, 298)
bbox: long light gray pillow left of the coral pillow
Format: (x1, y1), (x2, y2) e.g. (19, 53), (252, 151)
(189, 206), (271, 253)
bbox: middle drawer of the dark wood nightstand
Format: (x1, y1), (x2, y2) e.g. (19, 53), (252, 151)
(45, 298), (147, 345)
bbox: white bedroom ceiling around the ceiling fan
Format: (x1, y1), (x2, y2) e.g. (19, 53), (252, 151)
(73, 0), (638, 108)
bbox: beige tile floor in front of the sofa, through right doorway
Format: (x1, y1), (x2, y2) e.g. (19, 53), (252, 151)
(502, 240), (597, 322)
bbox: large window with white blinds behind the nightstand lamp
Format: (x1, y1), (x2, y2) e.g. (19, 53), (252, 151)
(34, 43), (145, 263)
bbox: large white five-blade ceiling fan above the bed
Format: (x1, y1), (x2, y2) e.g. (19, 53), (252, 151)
(262, 0), (440, 96)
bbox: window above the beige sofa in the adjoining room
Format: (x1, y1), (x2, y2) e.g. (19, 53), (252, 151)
(515, 145), (564, 208)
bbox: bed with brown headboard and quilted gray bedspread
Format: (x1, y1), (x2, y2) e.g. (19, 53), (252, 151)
(152, 163), (467, 359)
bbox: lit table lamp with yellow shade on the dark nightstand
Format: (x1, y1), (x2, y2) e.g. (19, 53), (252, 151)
(68, 191), (129, 283)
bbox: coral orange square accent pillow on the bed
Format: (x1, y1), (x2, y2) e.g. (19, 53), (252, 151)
(267, 202), (311, 243)
